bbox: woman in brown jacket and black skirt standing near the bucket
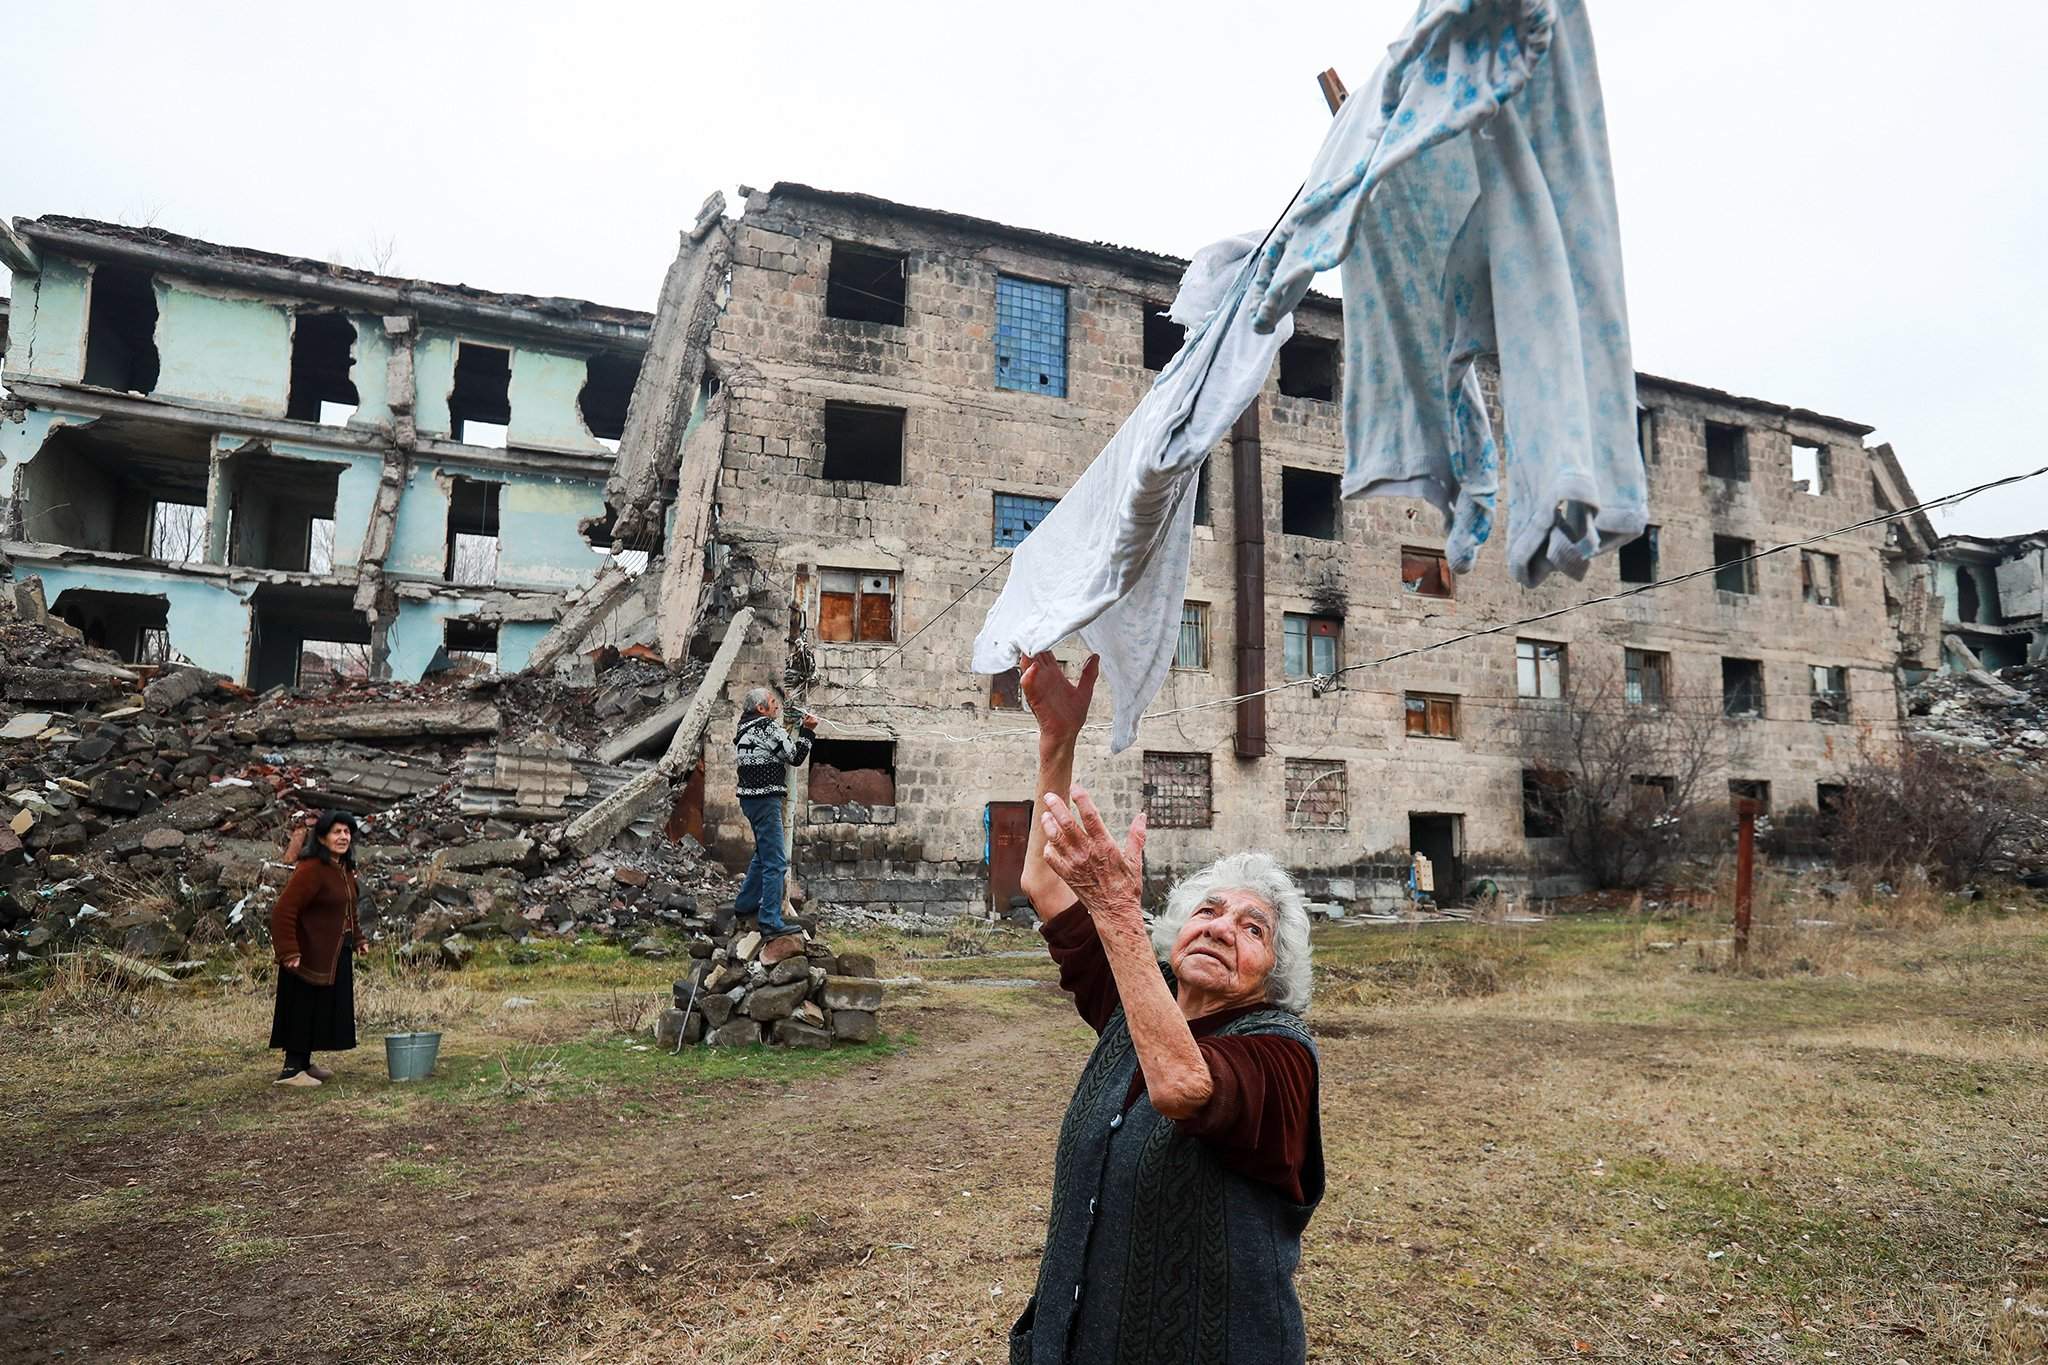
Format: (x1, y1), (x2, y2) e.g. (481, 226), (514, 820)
(270, 810), (369, 1087)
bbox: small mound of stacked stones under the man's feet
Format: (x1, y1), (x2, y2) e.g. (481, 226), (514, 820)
(655, 917), (883, 1050)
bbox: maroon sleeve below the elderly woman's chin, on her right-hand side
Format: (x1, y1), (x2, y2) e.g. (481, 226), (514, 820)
(1179, 1039), (1315, 1203)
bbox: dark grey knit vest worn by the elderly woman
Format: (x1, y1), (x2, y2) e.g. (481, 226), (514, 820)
(1010, 1009), (1323, 1365)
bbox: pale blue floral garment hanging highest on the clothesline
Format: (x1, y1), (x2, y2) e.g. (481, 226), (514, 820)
(1253, 0), (1647, 583)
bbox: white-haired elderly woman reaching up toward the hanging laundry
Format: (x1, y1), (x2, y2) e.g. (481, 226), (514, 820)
(1010, 655), (1323, 1365)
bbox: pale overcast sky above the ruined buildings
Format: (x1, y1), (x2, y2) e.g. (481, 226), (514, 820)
(16, 0), (2048, 534)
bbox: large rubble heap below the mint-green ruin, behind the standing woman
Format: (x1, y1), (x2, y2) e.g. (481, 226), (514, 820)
(0, 604), (731, 966)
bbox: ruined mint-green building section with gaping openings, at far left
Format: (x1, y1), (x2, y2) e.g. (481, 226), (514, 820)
(0, 217), (651, 688)
